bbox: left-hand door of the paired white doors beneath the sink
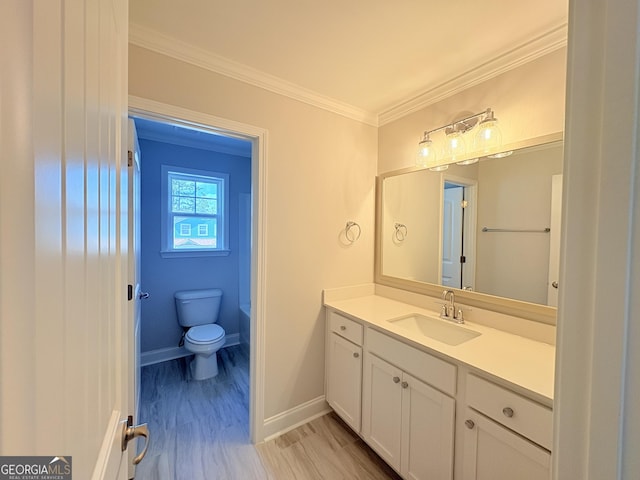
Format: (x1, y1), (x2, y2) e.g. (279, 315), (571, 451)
(362, 354), (402, 471)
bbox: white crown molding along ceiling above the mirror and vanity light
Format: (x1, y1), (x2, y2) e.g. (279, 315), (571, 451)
(378, 23), (567, 126)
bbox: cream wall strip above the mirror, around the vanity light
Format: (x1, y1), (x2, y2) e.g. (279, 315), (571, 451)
(378, 49), (566, 173)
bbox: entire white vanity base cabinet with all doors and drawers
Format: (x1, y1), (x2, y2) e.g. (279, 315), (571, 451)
(325, 299), (552, 480)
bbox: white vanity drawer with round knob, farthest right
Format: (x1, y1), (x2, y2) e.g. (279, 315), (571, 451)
(467, 374), (553, 450)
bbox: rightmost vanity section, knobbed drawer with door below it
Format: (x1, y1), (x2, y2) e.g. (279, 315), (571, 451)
(462, 374), (552, 480)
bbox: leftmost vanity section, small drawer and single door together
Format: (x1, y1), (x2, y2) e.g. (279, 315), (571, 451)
(326, 310), (363, 433)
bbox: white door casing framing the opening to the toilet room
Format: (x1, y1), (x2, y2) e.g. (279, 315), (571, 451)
(129, 97), (267, 443)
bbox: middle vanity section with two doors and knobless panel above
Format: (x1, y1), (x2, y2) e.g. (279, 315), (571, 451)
(362, 329), (456, 480)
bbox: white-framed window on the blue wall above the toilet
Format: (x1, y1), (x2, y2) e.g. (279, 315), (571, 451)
(162, 165), (229, 256)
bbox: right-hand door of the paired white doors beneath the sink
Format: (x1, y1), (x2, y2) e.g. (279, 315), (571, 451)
(400, 373), (456, 480)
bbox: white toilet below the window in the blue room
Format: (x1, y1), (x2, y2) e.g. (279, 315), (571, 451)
(175, 288), (225, 380)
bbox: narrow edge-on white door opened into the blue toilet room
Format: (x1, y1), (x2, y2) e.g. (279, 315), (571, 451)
(127, 119), (148, 478)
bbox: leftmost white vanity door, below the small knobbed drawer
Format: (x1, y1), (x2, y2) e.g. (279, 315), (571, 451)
(327, 333), (362, 433)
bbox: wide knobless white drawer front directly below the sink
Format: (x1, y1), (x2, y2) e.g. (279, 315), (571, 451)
(366, 328), (457, 396)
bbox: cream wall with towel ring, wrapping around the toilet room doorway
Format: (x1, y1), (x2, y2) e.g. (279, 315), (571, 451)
(129, 46), (377, 418)
